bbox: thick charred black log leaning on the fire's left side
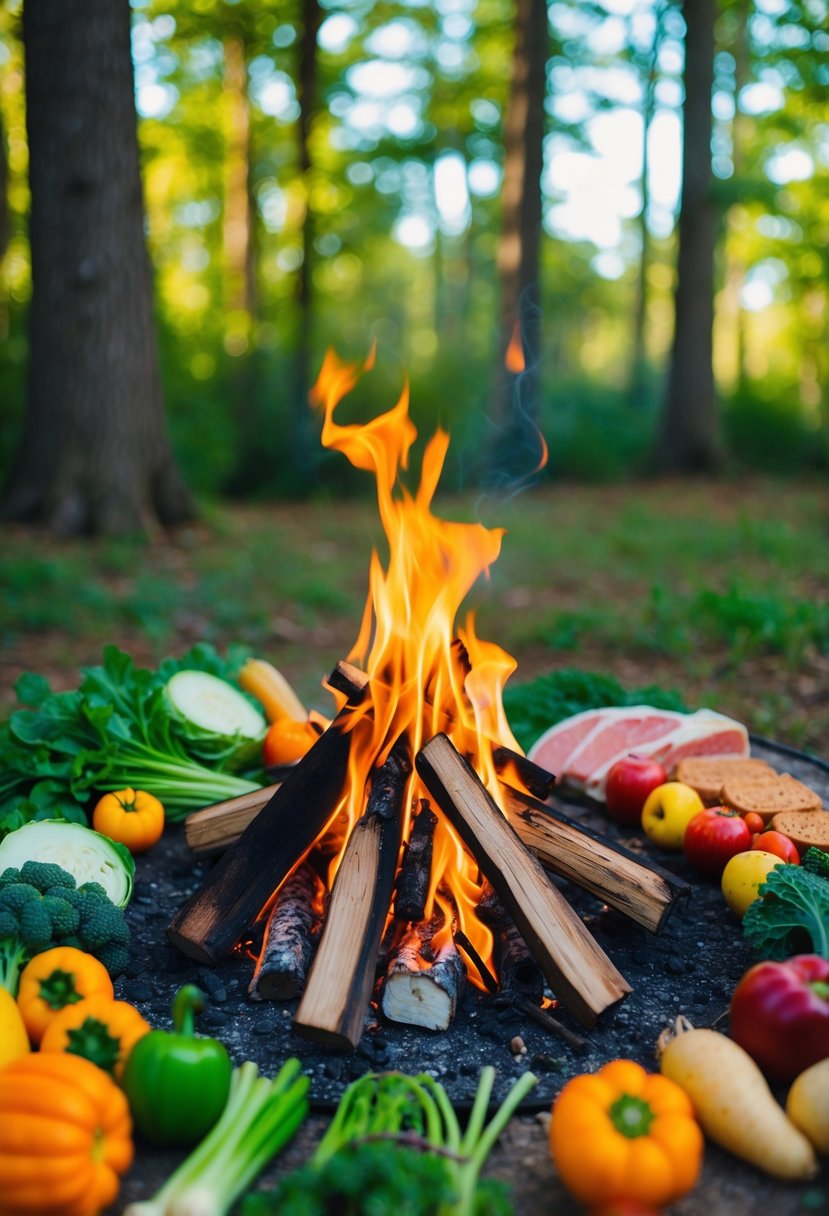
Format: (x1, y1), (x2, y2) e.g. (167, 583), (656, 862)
(167, 690), (367, 963)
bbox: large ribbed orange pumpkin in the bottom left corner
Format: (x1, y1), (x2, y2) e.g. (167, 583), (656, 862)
(0, 1053), (132, 1216)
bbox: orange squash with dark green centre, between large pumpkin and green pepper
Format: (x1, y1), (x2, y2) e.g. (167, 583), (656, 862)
(40, 995), (152, 1080)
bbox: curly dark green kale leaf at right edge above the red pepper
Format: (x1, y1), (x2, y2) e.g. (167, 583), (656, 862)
(743, 866), (829, 959)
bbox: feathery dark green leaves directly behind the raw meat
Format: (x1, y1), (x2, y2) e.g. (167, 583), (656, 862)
(503, 668), (688, 750)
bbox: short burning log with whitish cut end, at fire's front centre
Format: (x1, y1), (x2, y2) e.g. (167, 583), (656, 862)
(382, 922), (467, 1030)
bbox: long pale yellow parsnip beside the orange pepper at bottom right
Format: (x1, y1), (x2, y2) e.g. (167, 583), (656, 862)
(656, 1018), (818, 1181)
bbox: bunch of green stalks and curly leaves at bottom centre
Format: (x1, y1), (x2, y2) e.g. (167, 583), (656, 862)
(243, 1068), (536, 1216)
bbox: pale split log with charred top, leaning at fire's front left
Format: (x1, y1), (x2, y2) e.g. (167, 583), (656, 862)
(293, 747), (411, 1051)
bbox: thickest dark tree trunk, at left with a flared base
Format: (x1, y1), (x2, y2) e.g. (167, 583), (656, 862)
(2, 0), (192, 534)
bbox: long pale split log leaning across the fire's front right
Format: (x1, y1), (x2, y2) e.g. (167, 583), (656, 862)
(416, 734), (631, 1026)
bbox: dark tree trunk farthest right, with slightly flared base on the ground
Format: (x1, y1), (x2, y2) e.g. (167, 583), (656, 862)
(656, 0), (720, 473)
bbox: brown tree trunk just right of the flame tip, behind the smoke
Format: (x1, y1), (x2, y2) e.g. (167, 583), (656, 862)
(489, 0), (548, 482)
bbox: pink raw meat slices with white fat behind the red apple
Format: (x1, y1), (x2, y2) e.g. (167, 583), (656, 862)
(528, 705), (749, 799)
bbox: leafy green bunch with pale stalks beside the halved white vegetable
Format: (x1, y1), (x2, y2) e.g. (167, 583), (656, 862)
(0, 643), (263, 832)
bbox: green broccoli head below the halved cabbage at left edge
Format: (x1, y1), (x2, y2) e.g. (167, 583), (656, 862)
(0, 861), (130, 996)
